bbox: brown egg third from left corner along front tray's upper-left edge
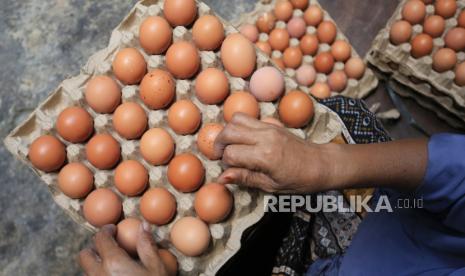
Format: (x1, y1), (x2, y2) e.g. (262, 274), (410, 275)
(85, 76), (121, 113)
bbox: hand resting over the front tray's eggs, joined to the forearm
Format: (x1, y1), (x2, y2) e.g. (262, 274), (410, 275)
(214, 113), (330, 193)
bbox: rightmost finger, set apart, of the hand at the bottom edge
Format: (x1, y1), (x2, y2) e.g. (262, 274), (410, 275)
(137, 221), (161, 268)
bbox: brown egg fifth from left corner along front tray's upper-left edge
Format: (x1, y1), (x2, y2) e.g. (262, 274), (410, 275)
(139, 16), (173, 55)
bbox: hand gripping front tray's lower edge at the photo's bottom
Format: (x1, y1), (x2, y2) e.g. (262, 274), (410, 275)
(79, 225), (168, 276)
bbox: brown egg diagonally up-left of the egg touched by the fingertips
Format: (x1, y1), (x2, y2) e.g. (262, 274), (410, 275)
(168, 100), (202, 135)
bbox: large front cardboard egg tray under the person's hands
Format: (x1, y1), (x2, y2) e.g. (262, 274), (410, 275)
(4, 0), (348, 275)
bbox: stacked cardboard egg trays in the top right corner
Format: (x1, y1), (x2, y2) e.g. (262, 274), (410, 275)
(367, 0), (465, 129)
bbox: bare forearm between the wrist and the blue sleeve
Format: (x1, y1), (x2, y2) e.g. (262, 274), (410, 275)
(321, 139), (428, 191)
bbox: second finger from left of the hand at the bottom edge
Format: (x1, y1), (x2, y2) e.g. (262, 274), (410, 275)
(94, 224), (127, 259)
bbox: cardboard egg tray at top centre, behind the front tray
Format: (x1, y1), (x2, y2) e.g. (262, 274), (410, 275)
(232, 0), (378, 99)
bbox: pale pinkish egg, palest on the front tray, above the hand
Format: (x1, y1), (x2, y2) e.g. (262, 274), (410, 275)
(249, 66), (284, 102)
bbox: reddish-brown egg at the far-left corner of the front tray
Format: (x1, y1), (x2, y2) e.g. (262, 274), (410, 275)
(28, 135), (66, 172)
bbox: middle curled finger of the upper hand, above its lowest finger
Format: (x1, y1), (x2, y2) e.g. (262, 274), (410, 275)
(222, 145), (265, 171)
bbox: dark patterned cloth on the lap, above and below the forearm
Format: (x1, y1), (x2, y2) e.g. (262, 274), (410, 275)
(273, 96), (391, 276)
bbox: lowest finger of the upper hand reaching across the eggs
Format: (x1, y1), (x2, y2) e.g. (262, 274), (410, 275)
(217, 168), (274, 192)
